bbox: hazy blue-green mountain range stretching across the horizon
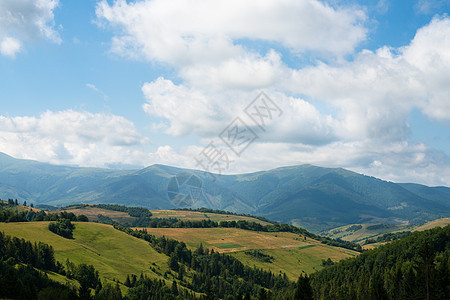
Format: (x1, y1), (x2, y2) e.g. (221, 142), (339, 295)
(0, 153), (450, 232)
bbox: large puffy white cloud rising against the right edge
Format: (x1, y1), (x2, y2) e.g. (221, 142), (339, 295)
(285, 18), (450, 141)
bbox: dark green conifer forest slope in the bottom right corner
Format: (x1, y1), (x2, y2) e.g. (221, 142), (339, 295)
(311, 225), (450, 299)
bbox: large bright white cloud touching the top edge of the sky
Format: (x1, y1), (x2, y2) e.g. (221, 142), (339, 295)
(96, 0), (366, 66)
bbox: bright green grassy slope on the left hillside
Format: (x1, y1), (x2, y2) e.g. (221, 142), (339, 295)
(0, 222), (168, 282)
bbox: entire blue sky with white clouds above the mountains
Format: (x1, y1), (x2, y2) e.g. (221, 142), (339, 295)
(0, 0), (450, 186)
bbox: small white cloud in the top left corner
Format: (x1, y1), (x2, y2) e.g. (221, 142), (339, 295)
(0, 0), (61, 57)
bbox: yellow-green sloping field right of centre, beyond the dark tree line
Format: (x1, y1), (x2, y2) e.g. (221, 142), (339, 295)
(135, 228), (358, 280)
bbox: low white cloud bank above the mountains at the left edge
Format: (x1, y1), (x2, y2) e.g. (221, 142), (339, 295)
(0, 110), (155, 166)
